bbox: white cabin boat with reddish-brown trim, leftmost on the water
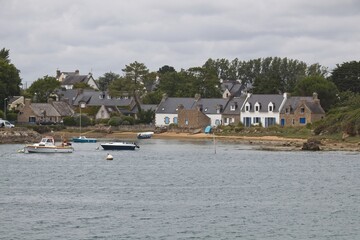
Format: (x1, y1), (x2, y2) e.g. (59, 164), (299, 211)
(25, 136), (74, 153)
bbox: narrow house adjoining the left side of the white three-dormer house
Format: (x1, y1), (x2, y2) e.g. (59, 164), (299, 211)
(222, 95), (246, 125)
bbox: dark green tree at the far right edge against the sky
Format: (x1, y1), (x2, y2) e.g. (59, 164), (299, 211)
(330, 61), (360, 93)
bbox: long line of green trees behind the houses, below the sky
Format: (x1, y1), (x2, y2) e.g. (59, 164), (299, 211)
(0, 48), (360, 116)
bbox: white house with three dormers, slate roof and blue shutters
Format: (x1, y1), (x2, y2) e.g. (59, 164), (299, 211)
(240, 93), (288, 127)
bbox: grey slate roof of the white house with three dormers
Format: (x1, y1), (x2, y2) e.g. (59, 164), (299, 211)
(241, 94), (284, 112)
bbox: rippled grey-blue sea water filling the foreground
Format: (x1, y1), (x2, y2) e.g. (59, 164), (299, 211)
(0, 139), (360, 240)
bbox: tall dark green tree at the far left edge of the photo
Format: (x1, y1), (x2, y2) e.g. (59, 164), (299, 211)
(0, 48), (21, 106)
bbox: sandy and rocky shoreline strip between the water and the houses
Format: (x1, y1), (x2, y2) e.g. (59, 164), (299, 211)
(0, 129), (360, 152)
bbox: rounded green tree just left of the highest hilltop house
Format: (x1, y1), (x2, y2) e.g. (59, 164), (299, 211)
(27, 75), (61, 102)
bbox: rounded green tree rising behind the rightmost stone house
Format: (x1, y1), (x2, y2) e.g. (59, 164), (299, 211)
(293, 76), (339, 111)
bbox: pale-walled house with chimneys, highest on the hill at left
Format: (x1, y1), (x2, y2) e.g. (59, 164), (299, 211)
(56, 70), (99, 90)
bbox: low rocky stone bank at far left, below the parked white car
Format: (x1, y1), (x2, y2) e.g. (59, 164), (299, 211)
(0, 128), (41, 144)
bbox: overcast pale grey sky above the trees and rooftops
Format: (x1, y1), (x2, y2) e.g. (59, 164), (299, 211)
(0, 0), (360, 87)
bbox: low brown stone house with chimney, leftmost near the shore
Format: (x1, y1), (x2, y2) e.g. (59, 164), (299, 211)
(17, 99), (74, 123)
